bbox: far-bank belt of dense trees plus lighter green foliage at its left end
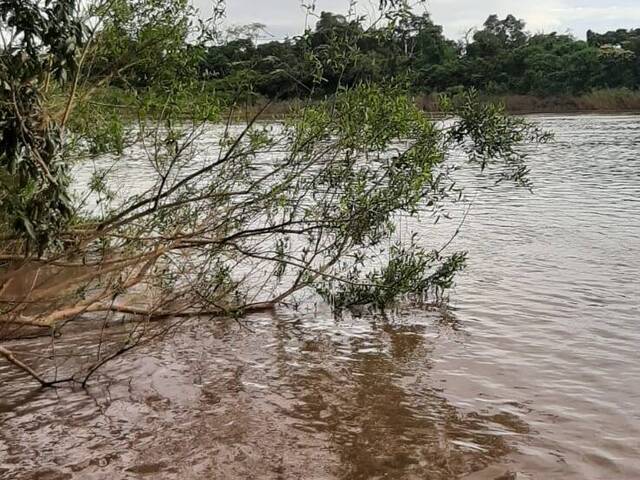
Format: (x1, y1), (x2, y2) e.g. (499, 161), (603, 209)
(81, 4), (640, 111)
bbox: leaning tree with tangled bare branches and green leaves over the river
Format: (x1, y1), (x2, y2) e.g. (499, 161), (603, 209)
(0, 0), (546, 386)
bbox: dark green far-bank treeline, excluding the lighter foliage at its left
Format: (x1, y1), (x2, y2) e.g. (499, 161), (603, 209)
(99, 12), (640, 100)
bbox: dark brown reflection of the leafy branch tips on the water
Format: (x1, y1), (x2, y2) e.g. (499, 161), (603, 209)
(282, 321), (526, 479)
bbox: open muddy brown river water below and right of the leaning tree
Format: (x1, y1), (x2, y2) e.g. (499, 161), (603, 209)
(0, 116), (640, 480)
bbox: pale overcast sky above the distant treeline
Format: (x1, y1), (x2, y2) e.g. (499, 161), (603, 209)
(193, 0), (640, 39)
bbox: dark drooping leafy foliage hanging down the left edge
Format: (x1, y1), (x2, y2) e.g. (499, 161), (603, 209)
(0, 0), (85, 254)
